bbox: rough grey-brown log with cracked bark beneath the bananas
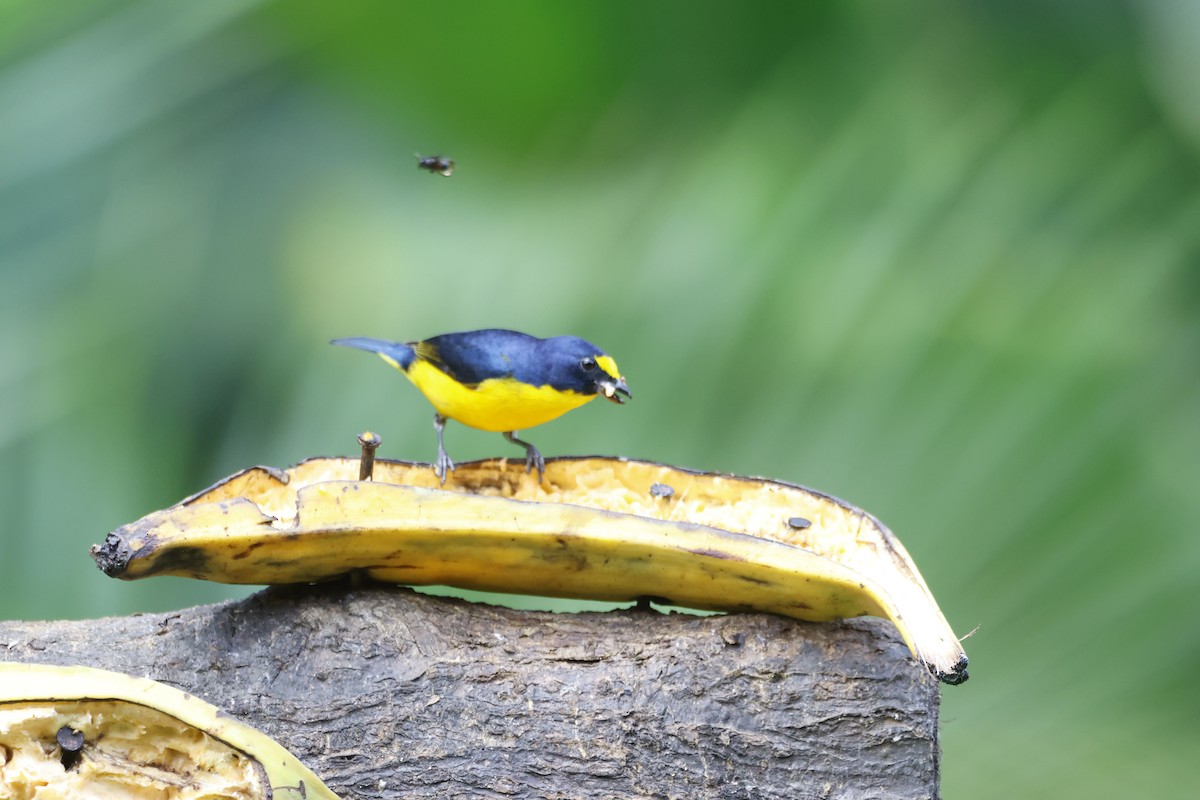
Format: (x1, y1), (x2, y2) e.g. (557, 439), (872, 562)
(0, 583), (938, 800)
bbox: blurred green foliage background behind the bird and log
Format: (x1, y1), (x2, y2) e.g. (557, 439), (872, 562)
(0, 0), (1200, 798)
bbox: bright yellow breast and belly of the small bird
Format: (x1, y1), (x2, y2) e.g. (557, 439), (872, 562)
(404, 359), (596, 432)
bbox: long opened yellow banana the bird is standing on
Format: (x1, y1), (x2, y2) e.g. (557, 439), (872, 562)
(92, 457), (967, 684)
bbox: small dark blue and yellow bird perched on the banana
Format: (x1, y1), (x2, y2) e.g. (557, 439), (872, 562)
(331, 329), (632, 485)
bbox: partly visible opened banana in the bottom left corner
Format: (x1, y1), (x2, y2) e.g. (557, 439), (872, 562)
(0, 663), (337, 800)
